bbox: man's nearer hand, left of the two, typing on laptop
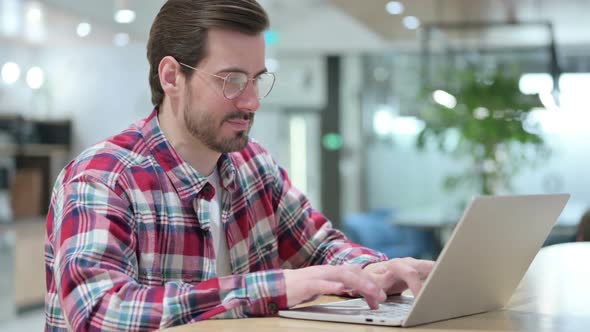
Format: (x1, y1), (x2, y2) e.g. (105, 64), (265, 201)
(284, 265), (387, 309)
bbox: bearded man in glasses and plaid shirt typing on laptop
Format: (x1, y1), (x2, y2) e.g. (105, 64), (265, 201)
(45, 0), (432, 330)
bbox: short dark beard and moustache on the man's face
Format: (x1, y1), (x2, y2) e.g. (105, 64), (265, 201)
(183, 99), (254, 153)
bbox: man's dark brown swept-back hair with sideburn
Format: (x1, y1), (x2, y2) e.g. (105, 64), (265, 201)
(147, 0), (269, 106)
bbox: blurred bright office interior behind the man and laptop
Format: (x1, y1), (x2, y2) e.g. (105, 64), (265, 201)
(0, 0), (590, 330)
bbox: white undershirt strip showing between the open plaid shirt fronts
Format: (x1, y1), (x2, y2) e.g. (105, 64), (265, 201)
(207, 169), (231, 277)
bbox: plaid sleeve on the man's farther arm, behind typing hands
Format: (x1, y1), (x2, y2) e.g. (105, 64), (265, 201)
(273, 166), (387, 268)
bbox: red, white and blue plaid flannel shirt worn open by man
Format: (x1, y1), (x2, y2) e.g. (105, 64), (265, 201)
(45, 109), (385, 331)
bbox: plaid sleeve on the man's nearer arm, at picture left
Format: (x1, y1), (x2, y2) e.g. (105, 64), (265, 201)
(48, 176), (287, 331)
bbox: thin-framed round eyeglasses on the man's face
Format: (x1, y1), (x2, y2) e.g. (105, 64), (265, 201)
(179, 62), (275, 100)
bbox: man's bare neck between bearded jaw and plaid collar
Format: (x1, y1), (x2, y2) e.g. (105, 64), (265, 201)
(158, 98), (221, 176)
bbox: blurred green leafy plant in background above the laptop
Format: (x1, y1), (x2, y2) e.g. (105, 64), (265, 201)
(416, 69), (549, 195)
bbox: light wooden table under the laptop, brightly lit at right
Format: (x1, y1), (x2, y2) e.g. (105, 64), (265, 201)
(166, 242), (590, 332)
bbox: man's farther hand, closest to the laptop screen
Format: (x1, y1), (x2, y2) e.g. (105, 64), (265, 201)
(364, 257), (434, 296)
